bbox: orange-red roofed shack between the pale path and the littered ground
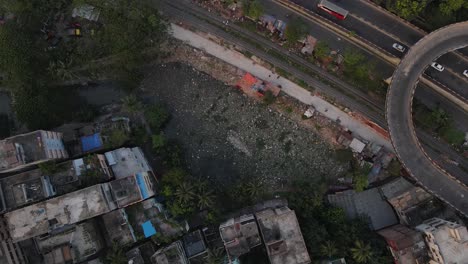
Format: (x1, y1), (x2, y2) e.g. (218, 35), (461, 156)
(236, 73), (281, 97)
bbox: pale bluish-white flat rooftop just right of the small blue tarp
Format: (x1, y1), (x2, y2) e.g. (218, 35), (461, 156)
(104, 147), (152, 179)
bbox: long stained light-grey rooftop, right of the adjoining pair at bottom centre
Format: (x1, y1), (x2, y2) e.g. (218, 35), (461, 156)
(255, 207), (311, 264)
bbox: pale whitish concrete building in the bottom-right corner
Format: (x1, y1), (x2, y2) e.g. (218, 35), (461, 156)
(416, 218), (468, 264)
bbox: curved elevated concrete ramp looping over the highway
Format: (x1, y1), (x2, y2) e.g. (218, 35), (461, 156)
(386, 22), (468, 216)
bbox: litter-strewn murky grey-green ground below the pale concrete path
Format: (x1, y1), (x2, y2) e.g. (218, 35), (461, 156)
(142, 62), (345, 190)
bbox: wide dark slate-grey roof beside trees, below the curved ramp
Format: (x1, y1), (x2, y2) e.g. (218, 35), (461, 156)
(327, 188), (398, 230)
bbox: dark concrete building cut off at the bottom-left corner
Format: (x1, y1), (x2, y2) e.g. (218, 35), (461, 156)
(0, 216), (28, 264)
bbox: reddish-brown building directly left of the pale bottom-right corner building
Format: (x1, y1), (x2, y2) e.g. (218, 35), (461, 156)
(377, 225), (428, 264)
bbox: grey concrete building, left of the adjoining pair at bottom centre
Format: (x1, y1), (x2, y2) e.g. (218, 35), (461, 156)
(219, 214), (262, 260)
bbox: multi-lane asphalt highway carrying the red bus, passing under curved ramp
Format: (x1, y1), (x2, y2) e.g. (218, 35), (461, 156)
(292, 0), (468, 100)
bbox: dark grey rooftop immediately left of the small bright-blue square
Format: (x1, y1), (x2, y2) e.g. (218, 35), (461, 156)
(102, 209), (137, 246)
